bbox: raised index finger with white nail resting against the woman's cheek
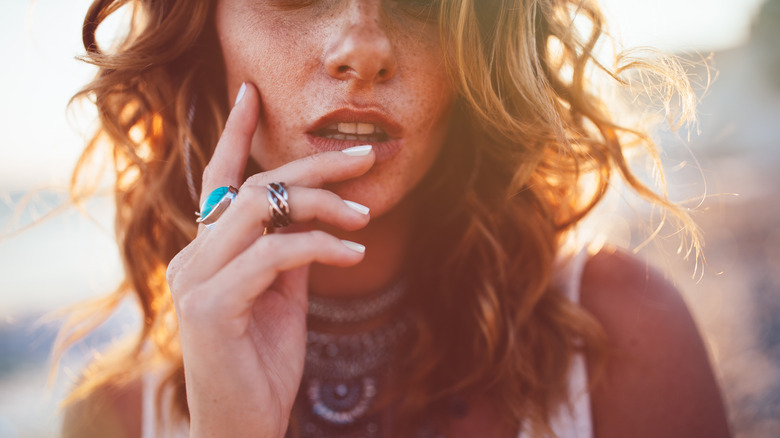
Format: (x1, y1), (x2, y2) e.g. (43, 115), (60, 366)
(201, 82), (260, 207)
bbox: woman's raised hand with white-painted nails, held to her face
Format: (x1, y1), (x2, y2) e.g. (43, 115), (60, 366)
(167, 84), (375, 437)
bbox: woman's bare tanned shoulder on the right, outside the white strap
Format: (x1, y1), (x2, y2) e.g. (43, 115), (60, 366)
(581, 250), (730, 438)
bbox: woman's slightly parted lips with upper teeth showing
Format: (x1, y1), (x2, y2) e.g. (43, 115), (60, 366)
(306, 109), (403, 162)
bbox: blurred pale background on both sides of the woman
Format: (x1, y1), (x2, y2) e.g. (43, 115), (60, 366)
(0, 0), (780, 438)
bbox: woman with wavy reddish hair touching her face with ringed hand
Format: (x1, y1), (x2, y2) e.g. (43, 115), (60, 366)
(59, 0), (728, 437)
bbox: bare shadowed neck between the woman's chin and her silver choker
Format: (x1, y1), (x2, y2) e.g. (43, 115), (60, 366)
(309, 196), (413, 298)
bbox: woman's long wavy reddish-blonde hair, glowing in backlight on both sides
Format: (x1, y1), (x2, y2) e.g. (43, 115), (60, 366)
(61, 0), (697, 435)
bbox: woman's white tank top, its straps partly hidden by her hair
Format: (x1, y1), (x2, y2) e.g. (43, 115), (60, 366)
(141, 250), (593, 438)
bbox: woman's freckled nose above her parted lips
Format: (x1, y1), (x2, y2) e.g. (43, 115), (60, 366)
(324, 0), (397, 83)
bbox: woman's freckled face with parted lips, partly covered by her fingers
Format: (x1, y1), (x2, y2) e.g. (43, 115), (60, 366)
(216, 0), (454, 217)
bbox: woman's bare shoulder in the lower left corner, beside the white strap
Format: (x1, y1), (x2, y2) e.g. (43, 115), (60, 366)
(62, 381), (142, 438)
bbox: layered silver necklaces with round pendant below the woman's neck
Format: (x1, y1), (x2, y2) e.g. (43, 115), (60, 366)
(295, 281), (437, 438)
